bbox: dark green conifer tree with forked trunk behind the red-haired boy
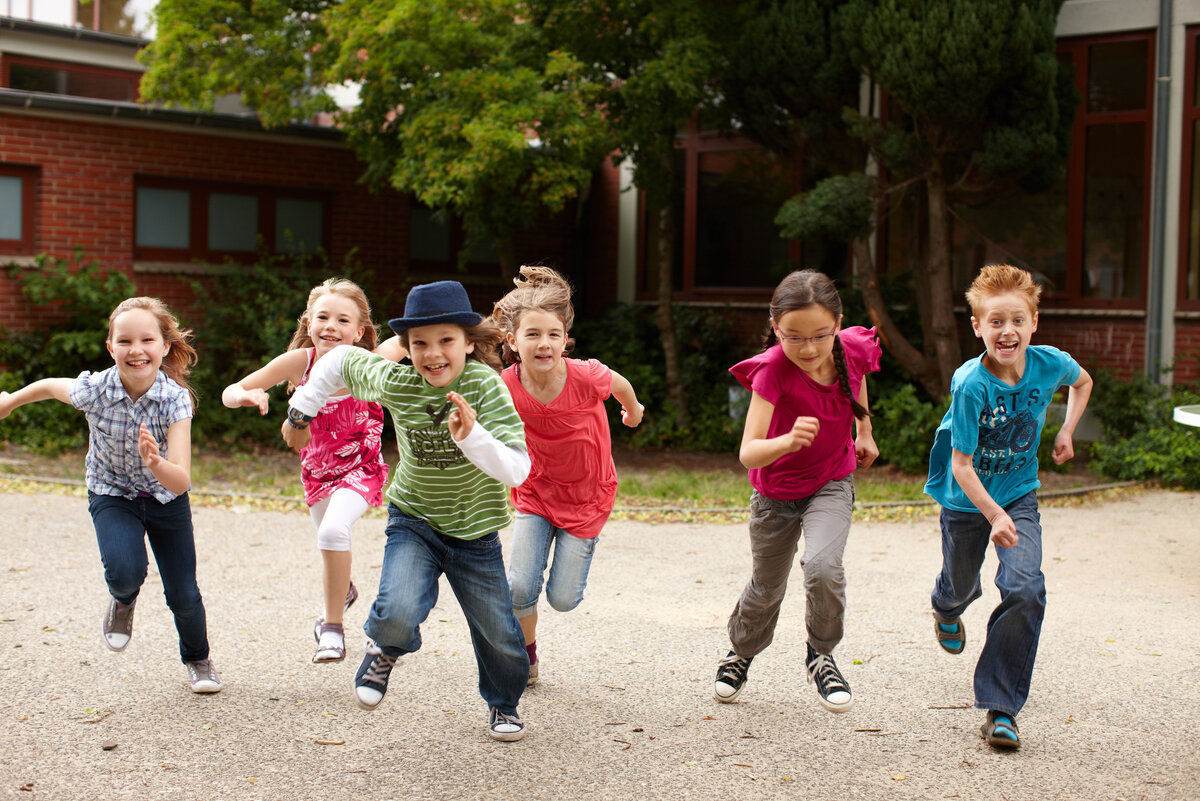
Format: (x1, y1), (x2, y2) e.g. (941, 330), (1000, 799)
(754, 0), (1076, 398)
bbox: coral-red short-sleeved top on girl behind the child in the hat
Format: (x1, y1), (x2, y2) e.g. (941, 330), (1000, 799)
(500, 359), (617, 540)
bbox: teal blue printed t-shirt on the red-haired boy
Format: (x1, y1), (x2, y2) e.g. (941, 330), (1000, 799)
(925, 345), (1080, 512)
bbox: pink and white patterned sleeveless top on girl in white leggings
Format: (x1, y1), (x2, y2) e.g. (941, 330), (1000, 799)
(300, 349), (388, 506)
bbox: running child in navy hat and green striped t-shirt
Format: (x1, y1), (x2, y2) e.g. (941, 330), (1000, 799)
(283, 281), (529, 741)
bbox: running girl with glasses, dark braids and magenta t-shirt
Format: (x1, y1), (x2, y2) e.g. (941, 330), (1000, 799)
(713, 270), (881, 712)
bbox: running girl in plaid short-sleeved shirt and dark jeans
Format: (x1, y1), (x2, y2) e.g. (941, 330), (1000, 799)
(0, 297), (221, 693)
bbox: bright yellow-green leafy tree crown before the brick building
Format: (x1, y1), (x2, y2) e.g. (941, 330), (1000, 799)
(142, 0), (611, 277)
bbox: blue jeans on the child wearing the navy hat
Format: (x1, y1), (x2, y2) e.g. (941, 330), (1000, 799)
(362, 504), (529, 715)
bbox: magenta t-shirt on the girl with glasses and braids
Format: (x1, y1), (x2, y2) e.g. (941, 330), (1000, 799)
(730, 326), (882, 500)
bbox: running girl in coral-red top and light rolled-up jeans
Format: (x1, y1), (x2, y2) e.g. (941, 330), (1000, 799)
(492, 266), (643, 685)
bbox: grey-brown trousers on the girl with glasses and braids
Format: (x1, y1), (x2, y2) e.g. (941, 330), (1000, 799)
(728, 476), (854, 658)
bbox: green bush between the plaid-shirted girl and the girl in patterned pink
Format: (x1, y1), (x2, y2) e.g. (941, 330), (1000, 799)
(192, 254), (390, 448)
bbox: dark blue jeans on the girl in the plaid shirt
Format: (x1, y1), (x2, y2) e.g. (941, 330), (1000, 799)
(88, 493), (209, 662)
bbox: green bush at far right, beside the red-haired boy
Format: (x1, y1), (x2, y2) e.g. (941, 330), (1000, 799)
(1090, 371), (1200, 489)
